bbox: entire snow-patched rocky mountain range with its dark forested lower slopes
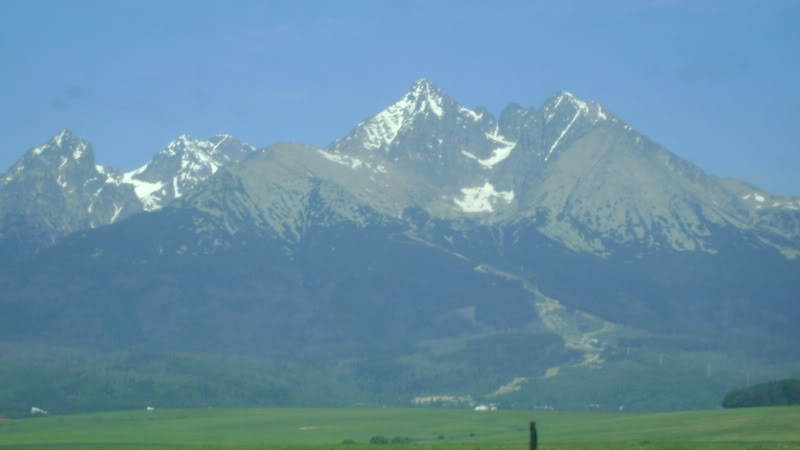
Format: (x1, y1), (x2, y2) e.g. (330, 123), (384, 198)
(0, 79), (800, 416)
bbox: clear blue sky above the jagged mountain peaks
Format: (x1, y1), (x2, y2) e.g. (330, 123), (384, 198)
(0, 0), (800, 195)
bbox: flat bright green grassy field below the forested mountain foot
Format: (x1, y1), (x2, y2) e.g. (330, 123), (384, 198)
(0, 407), (800, 450)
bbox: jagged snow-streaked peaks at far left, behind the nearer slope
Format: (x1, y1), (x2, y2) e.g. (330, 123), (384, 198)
(0, 130), (255, 258)
